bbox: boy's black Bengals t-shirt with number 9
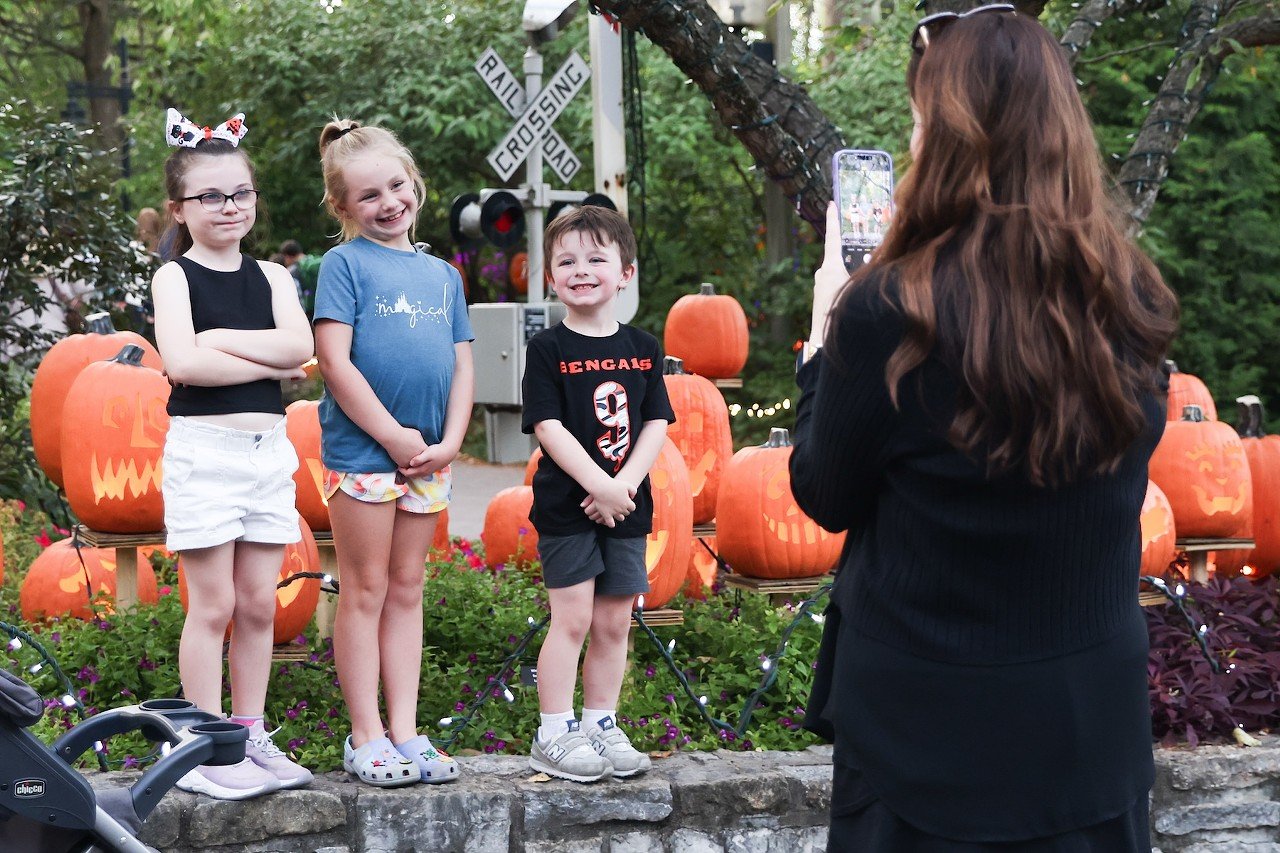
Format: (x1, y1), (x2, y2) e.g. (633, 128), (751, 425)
(521, 323), (676, 538)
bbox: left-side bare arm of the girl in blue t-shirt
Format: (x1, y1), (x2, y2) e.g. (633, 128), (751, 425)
(316, 319), (427, 467)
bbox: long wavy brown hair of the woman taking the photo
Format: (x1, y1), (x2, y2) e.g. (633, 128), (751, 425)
(832, 13), (1178, 485)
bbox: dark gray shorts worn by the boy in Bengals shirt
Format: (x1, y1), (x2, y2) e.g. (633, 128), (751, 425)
(538, 530), (649, 596)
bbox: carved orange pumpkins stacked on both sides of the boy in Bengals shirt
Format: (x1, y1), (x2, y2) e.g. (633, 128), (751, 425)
(481, 284), (844, 610)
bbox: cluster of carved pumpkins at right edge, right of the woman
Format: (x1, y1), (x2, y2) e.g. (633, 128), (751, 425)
(1142, 362), (1280, 578)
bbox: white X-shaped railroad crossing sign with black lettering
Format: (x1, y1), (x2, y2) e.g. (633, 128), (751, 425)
(475, 47), (591, 183)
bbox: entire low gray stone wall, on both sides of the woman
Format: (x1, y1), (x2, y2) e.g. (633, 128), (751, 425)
(92, 736), (1280, 853)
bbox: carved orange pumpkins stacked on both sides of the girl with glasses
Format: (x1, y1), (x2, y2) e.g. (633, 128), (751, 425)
(19, 314), (329, 630)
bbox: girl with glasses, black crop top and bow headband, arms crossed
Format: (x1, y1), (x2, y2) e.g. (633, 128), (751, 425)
(151, 110), (312, 799)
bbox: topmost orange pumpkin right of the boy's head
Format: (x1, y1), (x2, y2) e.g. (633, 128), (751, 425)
(662, 284), (748, 379)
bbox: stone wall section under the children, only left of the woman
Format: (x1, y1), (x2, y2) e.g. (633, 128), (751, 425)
(102, 747), (831, 853)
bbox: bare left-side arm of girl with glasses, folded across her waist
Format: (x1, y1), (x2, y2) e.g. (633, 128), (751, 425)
(151, 263), (306, 387)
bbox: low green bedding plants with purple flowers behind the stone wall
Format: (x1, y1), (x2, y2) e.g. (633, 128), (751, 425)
(0, 514), (820, 770)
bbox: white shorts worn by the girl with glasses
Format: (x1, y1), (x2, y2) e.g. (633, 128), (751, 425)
(161, 418), (302, 551)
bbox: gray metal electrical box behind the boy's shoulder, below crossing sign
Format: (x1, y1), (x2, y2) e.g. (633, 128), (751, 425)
(470, 302), (564, 462)
